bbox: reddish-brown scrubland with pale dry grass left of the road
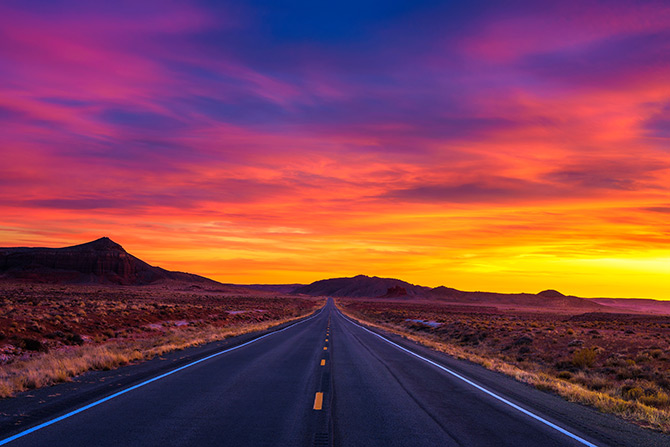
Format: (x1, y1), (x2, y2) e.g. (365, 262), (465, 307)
(0, 283), (323, 397)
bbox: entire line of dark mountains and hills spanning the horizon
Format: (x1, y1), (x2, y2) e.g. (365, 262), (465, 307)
(0, 242), (670, 314)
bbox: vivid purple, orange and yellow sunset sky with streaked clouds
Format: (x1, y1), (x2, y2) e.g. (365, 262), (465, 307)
(0, 0), (670, 299)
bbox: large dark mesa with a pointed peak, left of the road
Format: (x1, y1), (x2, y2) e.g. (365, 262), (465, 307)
(0, 237), (219, 285)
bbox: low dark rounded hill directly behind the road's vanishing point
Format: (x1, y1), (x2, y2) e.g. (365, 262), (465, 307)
(293, 275), (430, 298)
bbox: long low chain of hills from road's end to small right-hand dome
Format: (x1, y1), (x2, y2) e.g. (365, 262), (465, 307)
(293, 275), (606, 311)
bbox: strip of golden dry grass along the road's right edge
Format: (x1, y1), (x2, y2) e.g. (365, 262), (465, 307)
(338, 302), (670, 433)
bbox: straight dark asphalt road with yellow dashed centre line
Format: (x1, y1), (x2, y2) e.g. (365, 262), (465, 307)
(0, 300), (670, 447)
